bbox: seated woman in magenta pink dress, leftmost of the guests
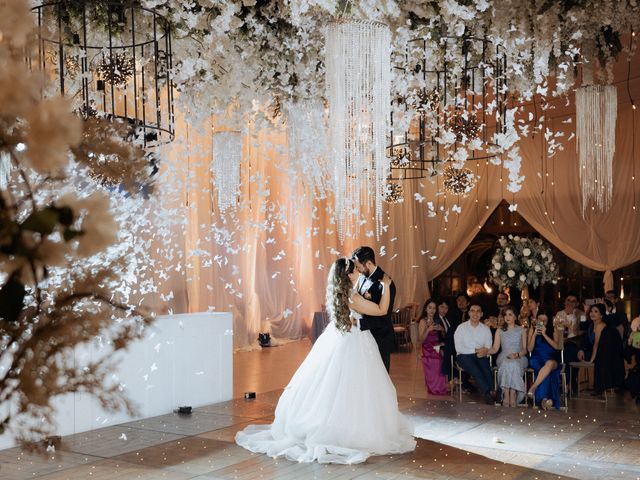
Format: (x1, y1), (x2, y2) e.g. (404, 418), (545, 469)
(418, 300), (448, 395)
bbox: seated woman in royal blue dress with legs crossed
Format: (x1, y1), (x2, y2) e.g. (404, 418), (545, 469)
(527, 313), (564, 410)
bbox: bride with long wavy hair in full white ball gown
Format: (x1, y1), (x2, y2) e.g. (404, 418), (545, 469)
(236, 258), (416, 464)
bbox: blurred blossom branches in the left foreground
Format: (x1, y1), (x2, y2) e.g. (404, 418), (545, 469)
(0, 0), (152, 446)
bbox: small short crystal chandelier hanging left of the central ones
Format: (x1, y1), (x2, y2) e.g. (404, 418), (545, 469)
(211, 130), (242, 213)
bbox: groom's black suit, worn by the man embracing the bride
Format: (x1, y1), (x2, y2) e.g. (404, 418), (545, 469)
(358, 267), (396, 372)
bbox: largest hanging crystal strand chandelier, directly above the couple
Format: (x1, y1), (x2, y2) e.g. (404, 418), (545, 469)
(325, 19), (391, 240)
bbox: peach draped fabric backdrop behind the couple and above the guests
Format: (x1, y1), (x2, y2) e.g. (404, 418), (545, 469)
(158, 79), (640, 348)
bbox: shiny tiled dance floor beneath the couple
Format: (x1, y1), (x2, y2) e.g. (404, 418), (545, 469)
(0, 341), (640, 480)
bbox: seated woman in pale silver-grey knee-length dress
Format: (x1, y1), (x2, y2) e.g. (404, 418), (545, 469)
(489, 307), (527, 407)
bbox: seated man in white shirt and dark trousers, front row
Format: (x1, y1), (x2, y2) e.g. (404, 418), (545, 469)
(453, 303), (495, 404)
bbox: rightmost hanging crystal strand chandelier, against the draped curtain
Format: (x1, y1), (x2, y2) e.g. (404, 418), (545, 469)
(576, 85), (618, 215)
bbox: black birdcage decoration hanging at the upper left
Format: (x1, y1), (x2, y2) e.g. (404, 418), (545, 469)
(30, 0), (175, 148)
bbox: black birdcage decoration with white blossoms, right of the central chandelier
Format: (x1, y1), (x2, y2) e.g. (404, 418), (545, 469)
(387, 36), (507, 180)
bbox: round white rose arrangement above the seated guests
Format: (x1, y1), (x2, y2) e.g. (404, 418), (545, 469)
(489, 235), (558, 290)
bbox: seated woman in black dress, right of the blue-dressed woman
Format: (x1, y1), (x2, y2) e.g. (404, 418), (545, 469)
(589, 303), (624, 394)
